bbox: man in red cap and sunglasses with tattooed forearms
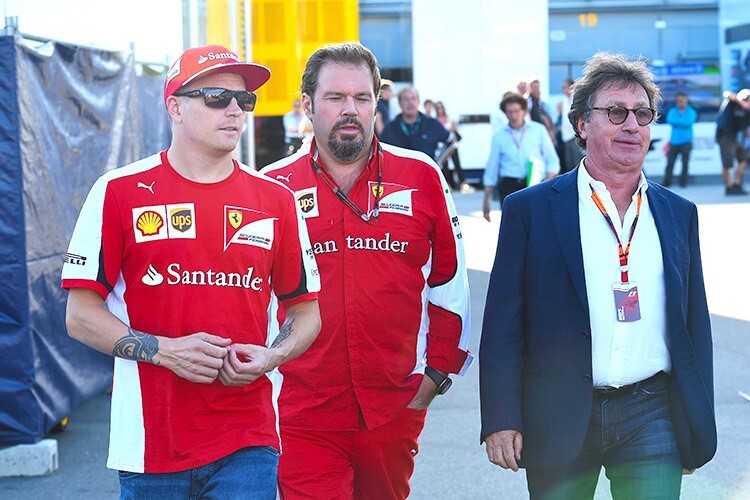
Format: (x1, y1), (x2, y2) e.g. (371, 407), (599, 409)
(62, 45), (320, 499)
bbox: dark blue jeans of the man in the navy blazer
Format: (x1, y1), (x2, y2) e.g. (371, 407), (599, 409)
(526, 375), (682, 500)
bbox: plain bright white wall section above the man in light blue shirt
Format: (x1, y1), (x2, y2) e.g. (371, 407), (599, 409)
(412, 0), (549, 115)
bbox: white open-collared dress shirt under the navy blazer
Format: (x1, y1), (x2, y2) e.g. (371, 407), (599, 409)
(578, 162), (671, 387)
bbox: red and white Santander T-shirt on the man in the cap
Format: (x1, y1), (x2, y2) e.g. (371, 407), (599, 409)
(62, 152), (320, 472)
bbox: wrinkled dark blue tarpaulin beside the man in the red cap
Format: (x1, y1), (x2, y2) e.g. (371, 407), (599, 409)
(0, 36), (169, 446)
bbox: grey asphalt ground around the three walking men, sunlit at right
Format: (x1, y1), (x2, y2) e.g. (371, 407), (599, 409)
(0, 181), (750, 500)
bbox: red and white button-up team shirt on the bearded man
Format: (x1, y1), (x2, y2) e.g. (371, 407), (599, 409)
(263, 139), (472, 431)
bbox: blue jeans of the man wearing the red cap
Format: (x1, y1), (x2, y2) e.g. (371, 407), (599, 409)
(119, 446), (279, 500)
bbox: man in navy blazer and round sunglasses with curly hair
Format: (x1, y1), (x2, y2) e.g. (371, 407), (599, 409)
(479, 53), (716, 499)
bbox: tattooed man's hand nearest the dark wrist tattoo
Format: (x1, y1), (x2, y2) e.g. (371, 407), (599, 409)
(153, 332), (232, 384)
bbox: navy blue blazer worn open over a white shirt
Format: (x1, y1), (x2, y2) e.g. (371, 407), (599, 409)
(479, 168), (716, 469)
